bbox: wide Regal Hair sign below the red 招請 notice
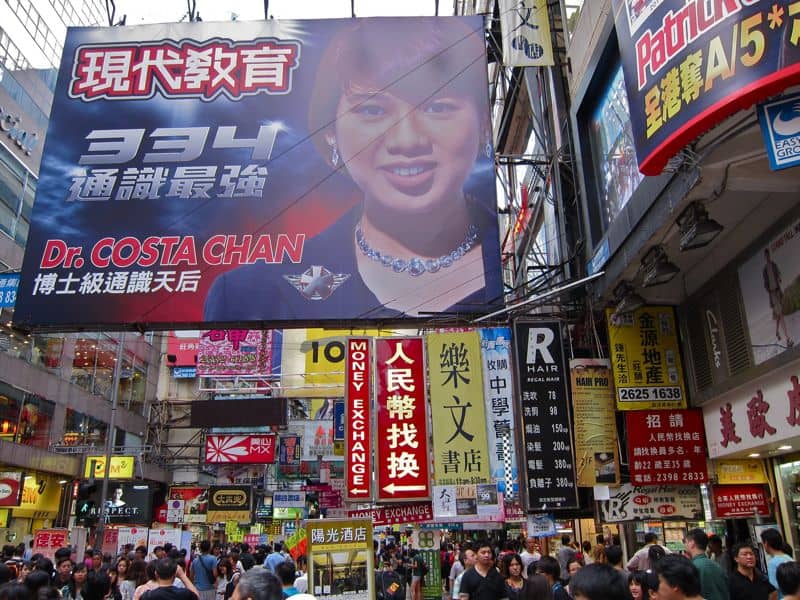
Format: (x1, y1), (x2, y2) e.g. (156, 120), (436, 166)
(597, 483), (703, 523)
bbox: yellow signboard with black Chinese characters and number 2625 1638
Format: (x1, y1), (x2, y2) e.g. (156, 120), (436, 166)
(606, 306), (686, 410)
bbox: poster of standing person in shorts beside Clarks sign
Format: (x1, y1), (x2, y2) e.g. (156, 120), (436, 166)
(739, 219), (800, 365)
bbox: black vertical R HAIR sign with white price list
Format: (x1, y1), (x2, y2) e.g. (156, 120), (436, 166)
(514, 321), (577, 511)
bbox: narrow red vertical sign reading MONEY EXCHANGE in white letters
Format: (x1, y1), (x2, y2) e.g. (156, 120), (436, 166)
(344, 338), (372, 501)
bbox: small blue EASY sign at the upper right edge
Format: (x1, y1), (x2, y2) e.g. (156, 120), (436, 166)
(758, 94), (800, 171)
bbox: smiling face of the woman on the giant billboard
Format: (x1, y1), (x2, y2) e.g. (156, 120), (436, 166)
(335, 90), (481, 213)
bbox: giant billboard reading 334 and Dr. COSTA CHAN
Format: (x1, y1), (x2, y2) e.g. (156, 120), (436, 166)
(15, 17), (502, 328)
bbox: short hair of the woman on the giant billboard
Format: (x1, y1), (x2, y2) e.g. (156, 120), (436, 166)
(308, 18), (488, 162)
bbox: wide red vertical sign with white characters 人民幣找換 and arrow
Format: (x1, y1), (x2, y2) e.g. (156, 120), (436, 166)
(375, 337), (431, 502)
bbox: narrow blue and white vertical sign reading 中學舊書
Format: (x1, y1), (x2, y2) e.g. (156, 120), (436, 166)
(478, 327), (519, 499)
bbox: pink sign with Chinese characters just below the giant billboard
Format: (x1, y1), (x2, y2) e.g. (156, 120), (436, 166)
(197, 329), (273, 377)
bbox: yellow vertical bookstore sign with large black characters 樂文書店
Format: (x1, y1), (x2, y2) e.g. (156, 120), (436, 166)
(426, 331), (492, 485)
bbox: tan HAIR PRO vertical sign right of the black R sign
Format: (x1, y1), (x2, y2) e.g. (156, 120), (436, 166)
(569, 358), (619, 487)
